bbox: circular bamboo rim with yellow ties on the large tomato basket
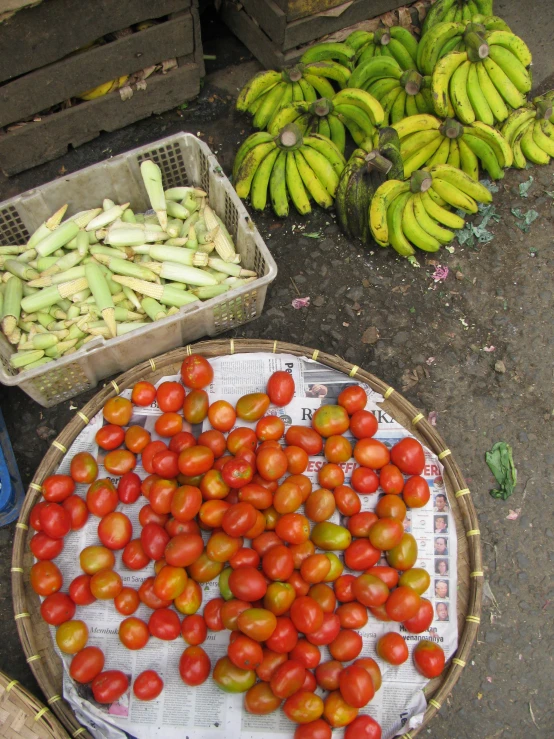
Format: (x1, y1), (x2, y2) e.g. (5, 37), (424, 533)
(12, 339), (484, 739)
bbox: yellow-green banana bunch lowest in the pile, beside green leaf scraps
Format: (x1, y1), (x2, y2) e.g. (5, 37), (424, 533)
(369, 164), (492, 257)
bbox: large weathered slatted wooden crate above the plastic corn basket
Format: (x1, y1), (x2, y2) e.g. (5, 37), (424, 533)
(0, 0), (204, 175)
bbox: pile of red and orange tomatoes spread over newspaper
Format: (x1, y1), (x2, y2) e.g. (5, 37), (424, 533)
(30, 355), (445, 739)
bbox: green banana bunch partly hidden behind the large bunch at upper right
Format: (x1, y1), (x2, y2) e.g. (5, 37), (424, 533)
(416, 16), (517, 74)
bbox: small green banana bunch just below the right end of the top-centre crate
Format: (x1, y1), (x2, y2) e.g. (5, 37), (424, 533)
(344, 26), (417, 70)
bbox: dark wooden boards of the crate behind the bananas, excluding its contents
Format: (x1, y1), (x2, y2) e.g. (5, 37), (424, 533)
(223, 0), (405, 53)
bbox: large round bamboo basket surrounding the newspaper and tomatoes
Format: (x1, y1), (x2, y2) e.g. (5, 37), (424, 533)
(12, 339), (483, 739)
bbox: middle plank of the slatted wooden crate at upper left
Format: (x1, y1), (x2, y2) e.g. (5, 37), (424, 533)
(0, 15), (194, 126)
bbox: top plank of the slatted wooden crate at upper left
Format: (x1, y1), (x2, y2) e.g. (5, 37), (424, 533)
(0, 0), (191, 82)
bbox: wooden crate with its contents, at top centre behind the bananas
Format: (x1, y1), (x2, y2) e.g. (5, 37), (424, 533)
(222, 0), (406, 69)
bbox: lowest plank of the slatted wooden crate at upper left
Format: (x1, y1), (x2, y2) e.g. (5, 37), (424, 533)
(0, 63), (200, 175)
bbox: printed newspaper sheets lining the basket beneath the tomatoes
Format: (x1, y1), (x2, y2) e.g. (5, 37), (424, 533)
(46, 354), (458, 739)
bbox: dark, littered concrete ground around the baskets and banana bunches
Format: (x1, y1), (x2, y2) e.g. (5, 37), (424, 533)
(0, 7), (554, 739)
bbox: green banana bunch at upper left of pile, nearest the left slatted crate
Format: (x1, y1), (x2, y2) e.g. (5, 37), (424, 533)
(236, 59), (353, 130)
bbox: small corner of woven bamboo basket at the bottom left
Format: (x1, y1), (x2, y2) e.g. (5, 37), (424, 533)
(0, 671), (69, 739)
